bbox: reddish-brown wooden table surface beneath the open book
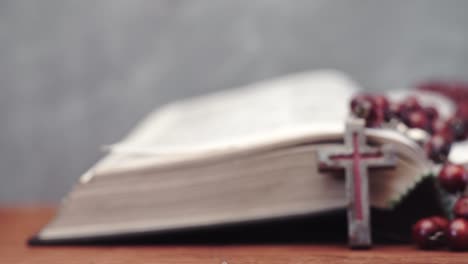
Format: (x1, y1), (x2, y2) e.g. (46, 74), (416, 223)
(0, 207), (468, 264)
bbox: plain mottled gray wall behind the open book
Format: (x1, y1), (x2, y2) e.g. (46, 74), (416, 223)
(0, 0), (468, 204)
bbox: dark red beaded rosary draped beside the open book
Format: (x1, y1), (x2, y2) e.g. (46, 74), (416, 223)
(350, 82), (468, 251)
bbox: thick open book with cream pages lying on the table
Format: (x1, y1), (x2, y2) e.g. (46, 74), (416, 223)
(35, 70), (442, 243)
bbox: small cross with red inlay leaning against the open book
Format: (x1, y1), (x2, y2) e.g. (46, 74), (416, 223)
(318, 117), (396, 248)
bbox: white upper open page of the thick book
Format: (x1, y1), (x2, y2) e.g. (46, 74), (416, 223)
(112, 71), (357, 154)
